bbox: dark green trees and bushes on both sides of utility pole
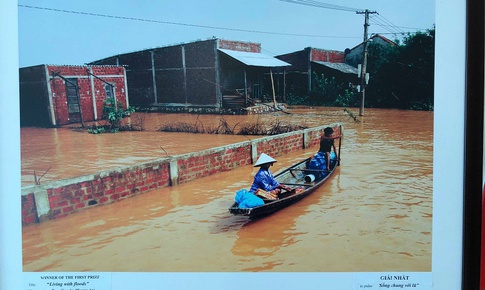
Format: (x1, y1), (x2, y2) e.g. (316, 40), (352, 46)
(286, 28), (435, 111)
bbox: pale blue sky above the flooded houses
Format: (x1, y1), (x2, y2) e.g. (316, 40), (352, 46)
(18, 0), (435, 67)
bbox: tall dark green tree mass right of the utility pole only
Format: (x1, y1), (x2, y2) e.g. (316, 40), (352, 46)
(365, 29), (435, 110)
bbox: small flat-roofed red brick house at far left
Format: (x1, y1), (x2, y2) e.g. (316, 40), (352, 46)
(19, 64), (129, 127)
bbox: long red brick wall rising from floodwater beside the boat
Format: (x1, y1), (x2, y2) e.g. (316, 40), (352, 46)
(21, 124), (340, 225)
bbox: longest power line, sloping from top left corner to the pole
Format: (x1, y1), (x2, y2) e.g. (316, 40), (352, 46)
(18, 4), (356, 38)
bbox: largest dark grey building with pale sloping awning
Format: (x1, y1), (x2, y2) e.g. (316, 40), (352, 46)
(90, 38), (289, 111)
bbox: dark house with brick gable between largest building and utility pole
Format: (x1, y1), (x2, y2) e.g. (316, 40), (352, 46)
(276, 47), (357, 95)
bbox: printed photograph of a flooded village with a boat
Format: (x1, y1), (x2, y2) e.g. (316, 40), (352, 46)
(18, 0), (434, 276)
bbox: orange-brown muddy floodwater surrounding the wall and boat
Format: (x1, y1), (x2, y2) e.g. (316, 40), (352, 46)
(21, 108), (433, 272)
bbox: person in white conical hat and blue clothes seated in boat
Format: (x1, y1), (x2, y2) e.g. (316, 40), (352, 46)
(249, 153), (291, 194)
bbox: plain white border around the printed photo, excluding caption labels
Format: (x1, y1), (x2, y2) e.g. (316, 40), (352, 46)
(0, 0), (466, 290)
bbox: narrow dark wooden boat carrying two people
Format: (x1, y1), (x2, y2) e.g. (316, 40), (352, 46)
(229, 158), (338, 218)
